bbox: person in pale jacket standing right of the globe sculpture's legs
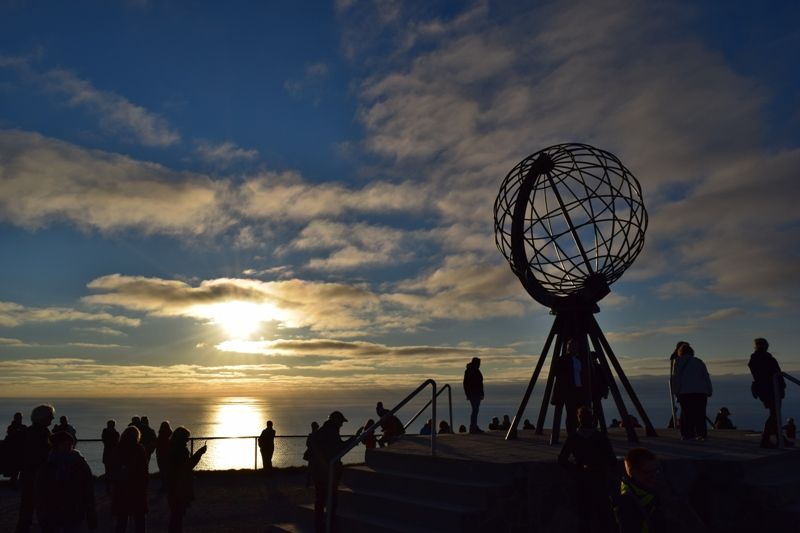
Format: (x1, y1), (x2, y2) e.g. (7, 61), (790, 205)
(672, 342), (713, 441)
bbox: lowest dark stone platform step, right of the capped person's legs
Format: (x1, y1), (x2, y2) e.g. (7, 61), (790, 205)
(339, 487), (485, 532)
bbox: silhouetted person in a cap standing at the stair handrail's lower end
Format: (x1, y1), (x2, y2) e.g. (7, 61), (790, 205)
(310, 411), (363, 533)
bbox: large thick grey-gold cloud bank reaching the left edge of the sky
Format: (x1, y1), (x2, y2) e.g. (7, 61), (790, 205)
(0, 130), (232, 236)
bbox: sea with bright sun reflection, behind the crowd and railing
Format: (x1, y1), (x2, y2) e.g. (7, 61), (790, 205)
(0, 376), (800, 474)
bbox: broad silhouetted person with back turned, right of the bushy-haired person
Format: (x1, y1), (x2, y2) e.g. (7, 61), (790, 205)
(35, 431), (97, 533)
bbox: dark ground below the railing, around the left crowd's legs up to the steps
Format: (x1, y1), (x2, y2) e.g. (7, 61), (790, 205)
(0, 468), (314, 532)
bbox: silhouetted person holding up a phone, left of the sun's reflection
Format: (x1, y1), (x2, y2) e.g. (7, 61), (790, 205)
(167, 426), (207, 533)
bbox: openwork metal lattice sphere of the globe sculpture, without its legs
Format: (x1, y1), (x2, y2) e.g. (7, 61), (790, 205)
(494, 144), (647, 306)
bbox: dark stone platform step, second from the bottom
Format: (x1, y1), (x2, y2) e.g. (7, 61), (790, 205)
(342, 465), (509, 508)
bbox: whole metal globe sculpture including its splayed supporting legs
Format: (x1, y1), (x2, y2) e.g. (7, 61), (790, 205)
(494, 143), (655, 443)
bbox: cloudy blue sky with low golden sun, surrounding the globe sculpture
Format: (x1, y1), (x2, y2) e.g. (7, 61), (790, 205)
(0, 0), (800, 397)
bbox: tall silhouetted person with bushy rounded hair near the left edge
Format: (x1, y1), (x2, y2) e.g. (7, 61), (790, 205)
(17, 405), (56, 533)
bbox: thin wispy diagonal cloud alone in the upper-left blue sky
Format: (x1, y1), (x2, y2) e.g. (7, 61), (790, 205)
(39, 69), (180, 146)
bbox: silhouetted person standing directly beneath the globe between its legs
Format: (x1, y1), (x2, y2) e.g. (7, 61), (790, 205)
(550, 339), (608, 435)
